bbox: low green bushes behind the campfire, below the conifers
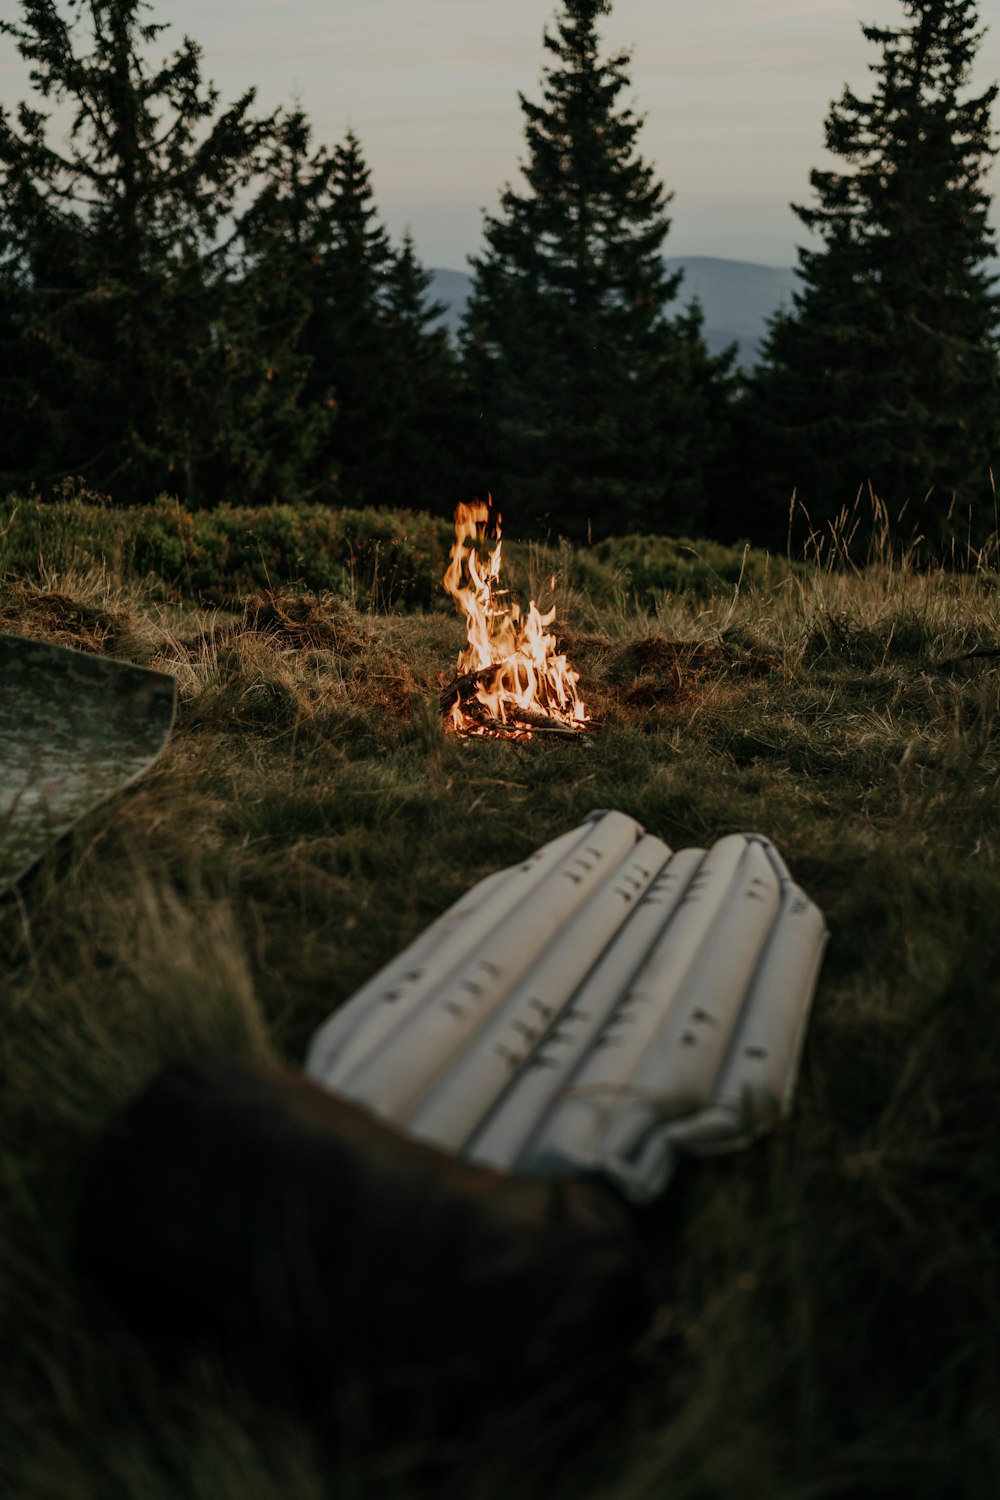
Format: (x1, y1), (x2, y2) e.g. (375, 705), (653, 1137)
(0, 491), (795, 609)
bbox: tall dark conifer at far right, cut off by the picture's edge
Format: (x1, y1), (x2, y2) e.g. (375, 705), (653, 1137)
(748, 0), (1000, 534)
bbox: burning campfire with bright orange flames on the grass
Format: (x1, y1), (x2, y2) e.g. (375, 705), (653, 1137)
(441, 501), (589, 740)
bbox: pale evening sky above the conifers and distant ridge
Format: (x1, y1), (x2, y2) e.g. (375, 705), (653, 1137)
(0, 0), (1000, 270)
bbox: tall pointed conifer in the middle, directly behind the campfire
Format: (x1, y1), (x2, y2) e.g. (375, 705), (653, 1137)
(463, 0), (732, 537)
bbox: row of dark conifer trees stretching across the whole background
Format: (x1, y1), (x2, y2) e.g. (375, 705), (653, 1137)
(0, 0), (1000, 543)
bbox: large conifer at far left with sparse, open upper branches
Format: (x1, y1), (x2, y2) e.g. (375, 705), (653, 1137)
(0, 0), (301, 503)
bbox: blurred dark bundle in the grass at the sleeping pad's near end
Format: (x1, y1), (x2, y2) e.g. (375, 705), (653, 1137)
(78, 1062), (649, 1386)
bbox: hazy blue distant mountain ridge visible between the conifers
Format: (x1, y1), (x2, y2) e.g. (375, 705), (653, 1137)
(430, 255), (796, 368)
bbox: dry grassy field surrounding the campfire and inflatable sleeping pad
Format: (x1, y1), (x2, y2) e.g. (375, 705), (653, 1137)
(0, 500), (1000, 1500)
